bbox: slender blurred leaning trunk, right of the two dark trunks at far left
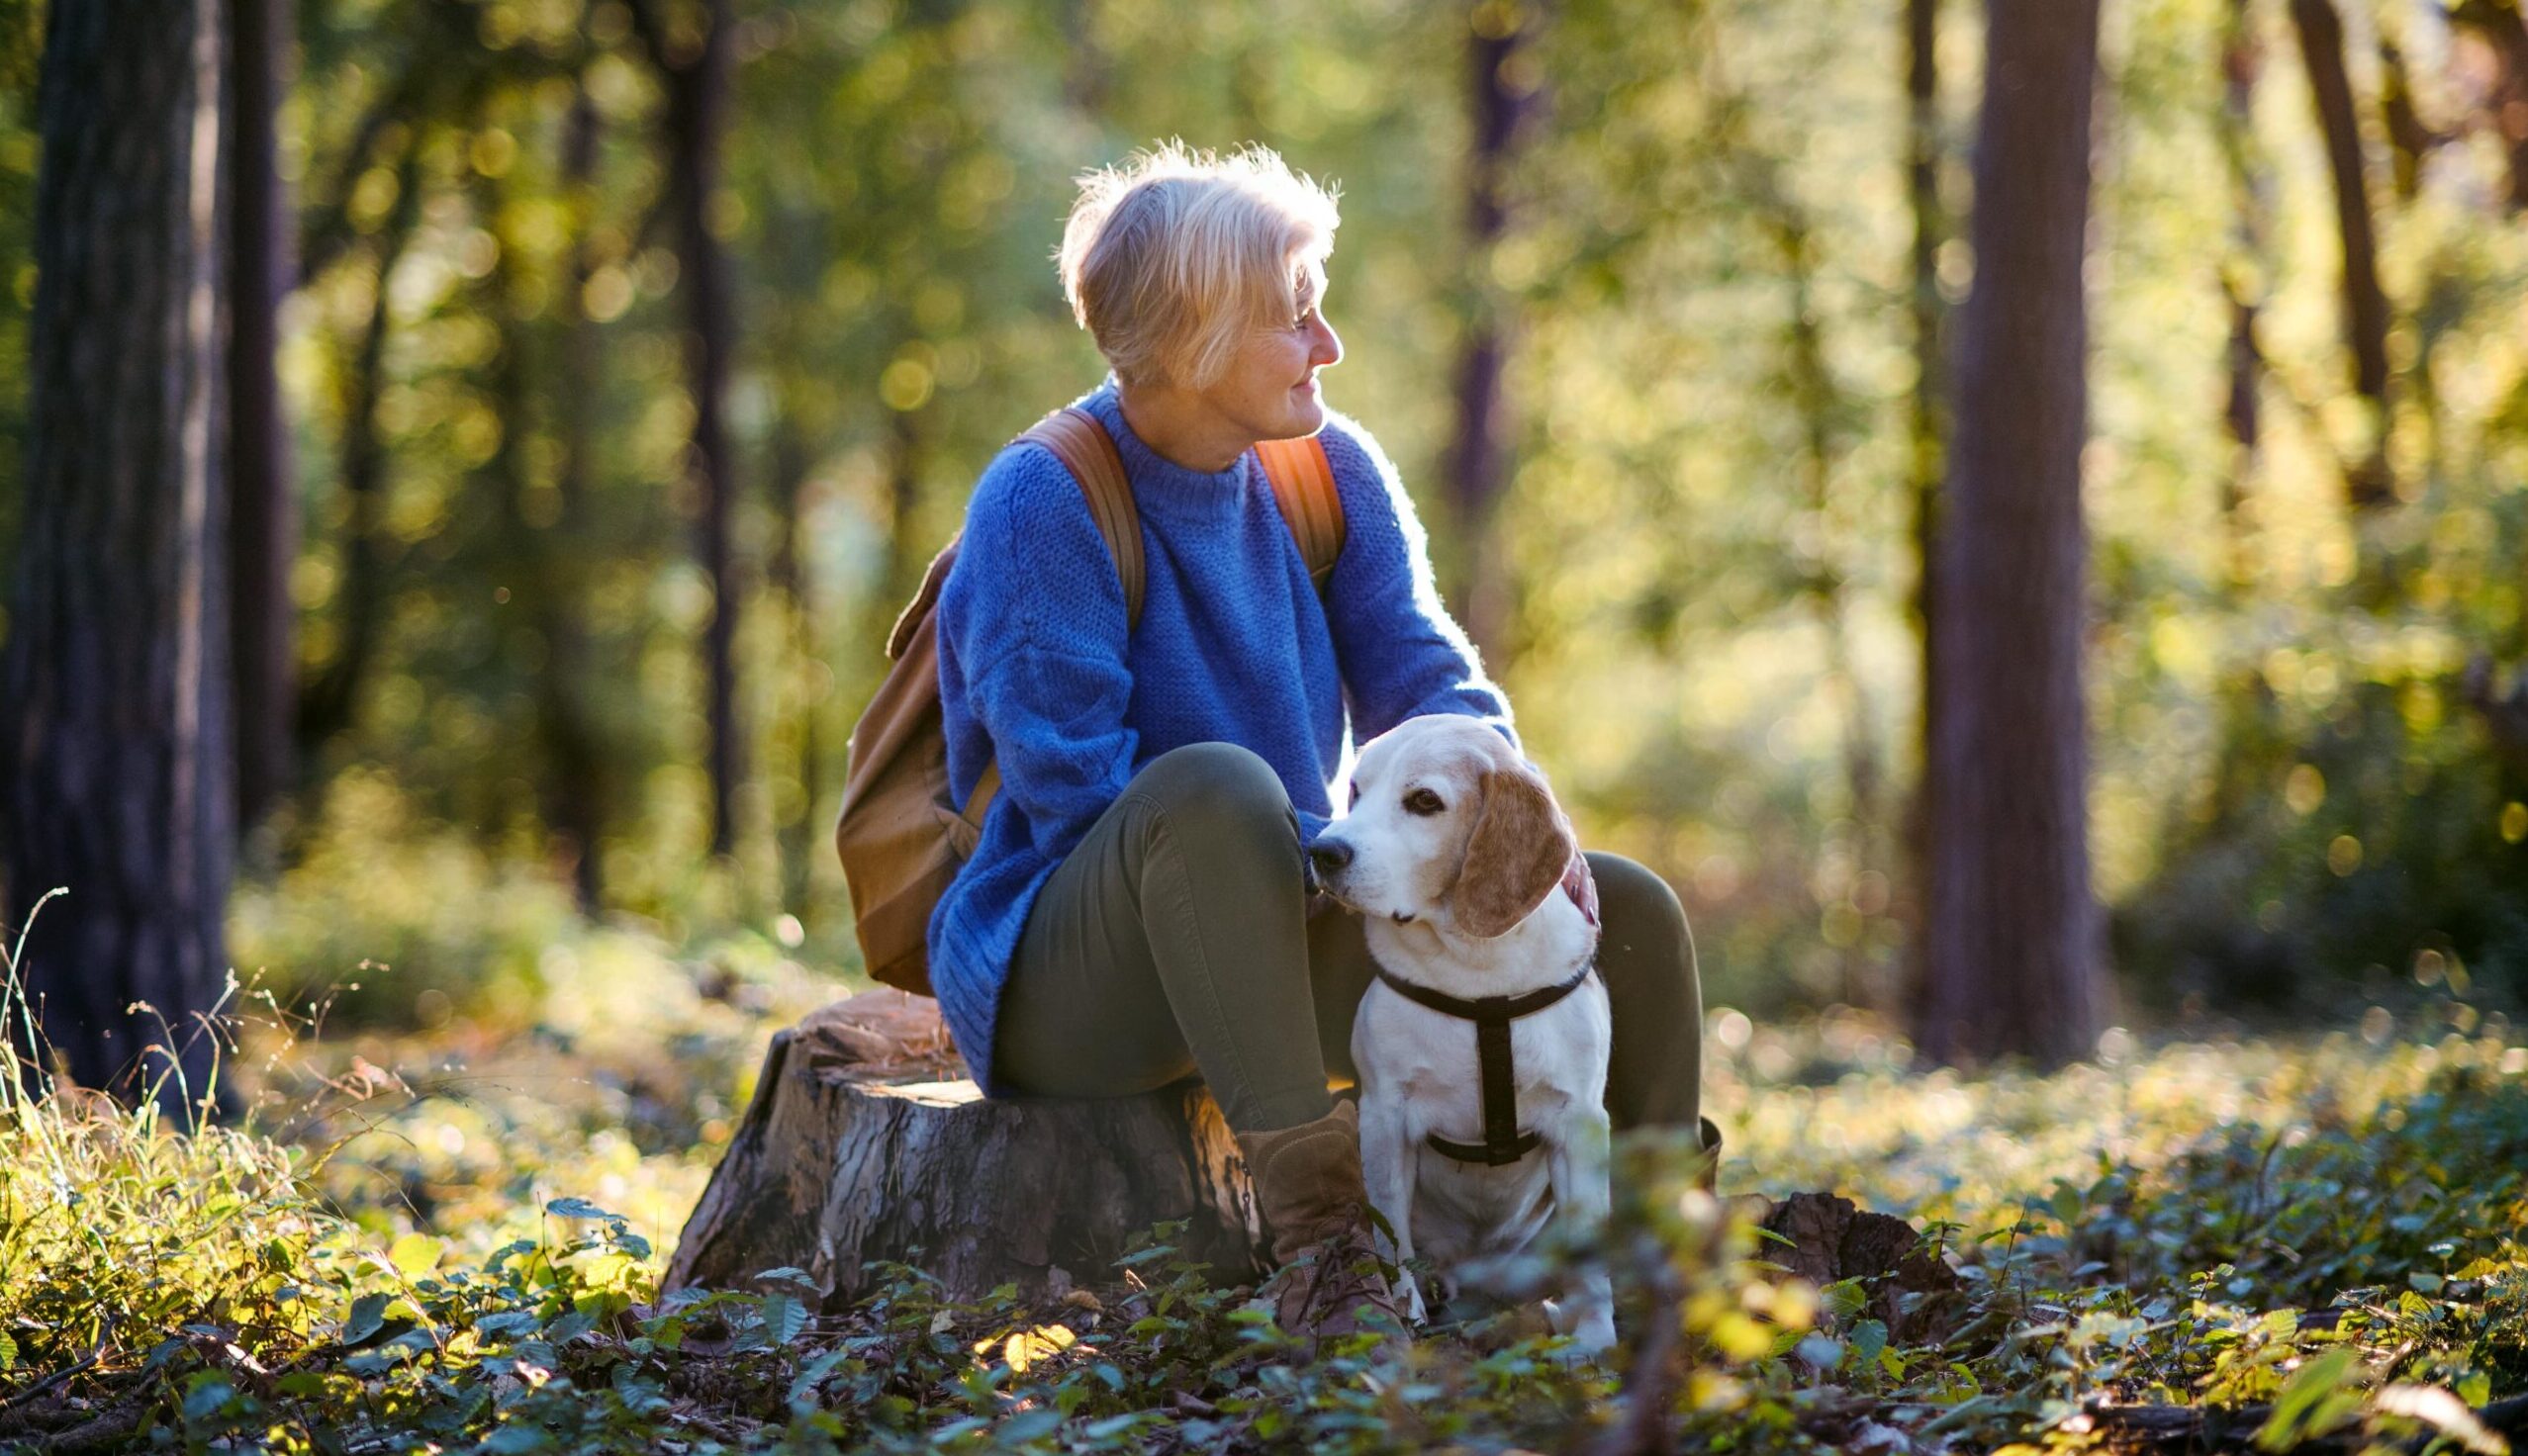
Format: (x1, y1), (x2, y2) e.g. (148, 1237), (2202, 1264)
(298, 151), (422, 764)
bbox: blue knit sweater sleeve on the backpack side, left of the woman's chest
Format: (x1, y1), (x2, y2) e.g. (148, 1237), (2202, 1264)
(938, 445), (1138, 860)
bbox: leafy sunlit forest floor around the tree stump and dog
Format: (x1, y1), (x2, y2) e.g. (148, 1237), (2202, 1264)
(0, 925), (2528, 1453)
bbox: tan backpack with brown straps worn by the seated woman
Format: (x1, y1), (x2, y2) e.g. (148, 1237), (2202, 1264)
(834, 407), (1343, 996)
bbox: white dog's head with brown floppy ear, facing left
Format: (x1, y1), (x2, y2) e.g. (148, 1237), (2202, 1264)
(1309, 713), (1577, 941)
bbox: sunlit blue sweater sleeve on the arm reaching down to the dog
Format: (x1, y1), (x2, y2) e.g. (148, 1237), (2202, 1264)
(1322, 414), (1520, 746)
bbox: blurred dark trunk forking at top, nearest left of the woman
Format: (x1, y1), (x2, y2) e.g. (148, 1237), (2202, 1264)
(632, 0), (746, 855)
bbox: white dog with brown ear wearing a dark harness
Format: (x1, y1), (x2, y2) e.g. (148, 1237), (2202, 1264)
(1309, 713), (1616, 1352)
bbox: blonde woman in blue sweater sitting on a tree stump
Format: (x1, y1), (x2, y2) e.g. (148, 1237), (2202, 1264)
(928, 146), (1702, 1334)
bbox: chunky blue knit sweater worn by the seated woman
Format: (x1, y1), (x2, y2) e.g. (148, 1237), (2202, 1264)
(930, 379), (1509, 1095)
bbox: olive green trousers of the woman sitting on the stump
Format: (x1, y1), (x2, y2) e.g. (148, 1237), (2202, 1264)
(993, 743), (1704, 1133)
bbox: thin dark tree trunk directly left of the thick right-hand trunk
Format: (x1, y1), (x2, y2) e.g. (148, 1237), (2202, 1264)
(1904, 0), (1949, 1021)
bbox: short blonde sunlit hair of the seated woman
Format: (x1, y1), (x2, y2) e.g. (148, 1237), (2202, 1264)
(1054, 141), (1340, 390)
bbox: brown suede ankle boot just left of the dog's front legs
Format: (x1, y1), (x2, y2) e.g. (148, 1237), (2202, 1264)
(1239, 1102), (1411, 1339)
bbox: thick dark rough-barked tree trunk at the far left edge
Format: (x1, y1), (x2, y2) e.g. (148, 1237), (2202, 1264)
(0, 0), (237, 1107)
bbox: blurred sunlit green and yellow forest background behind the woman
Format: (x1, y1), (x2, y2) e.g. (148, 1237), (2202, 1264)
(0, 0), (2528, 1086)
